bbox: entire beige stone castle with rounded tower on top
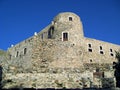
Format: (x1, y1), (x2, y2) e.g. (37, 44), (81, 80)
(0, 12), (120, 88)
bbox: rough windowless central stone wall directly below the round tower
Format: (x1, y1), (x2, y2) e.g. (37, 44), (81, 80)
(32, 36), (83, 71)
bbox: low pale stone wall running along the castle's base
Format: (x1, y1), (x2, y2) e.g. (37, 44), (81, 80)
(3, 70), (115, 89)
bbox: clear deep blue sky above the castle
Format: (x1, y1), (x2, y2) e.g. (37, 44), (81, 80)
(0, 0), (120, 50)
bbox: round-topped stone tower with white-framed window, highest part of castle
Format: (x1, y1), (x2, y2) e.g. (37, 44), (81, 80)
(52, 12), (84, 43)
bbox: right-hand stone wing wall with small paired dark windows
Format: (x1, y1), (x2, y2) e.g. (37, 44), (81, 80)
(81, 38), (120, 63)
